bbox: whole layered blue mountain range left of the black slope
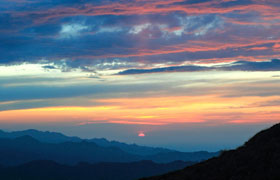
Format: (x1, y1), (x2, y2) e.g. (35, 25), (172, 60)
(0, 130), (214, 180)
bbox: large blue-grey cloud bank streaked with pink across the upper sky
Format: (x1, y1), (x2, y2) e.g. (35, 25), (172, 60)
(0, 0), (280, 72)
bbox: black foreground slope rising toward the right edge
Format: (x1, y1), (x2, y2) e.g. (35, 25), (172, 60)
(142, 124), (280, 180)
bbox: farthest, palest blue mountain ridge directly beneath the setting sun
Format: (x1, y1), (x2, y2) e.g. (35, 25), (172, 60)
(0, 129), (219, 163)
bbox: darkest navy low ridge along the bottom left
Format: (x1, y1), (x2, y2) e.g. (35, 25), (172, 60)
(0, 161), (195, 180)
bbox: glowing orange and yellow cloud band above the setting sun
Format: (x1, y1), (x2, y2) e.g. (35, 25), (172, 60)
(0, 96), (280, 125)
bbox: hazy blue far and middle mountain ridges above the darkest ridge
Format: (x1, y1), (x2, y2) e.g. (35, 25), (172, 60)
(0, 130), (218, 166)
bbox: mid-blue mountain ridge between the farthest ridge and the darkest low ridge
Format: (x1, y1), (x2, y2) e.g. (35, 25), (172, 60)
(0, 136), (218, 166)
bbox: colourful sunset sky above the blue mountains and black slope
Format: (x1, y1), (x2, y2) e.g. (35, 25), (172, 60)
(0, 0), (280, 151)
